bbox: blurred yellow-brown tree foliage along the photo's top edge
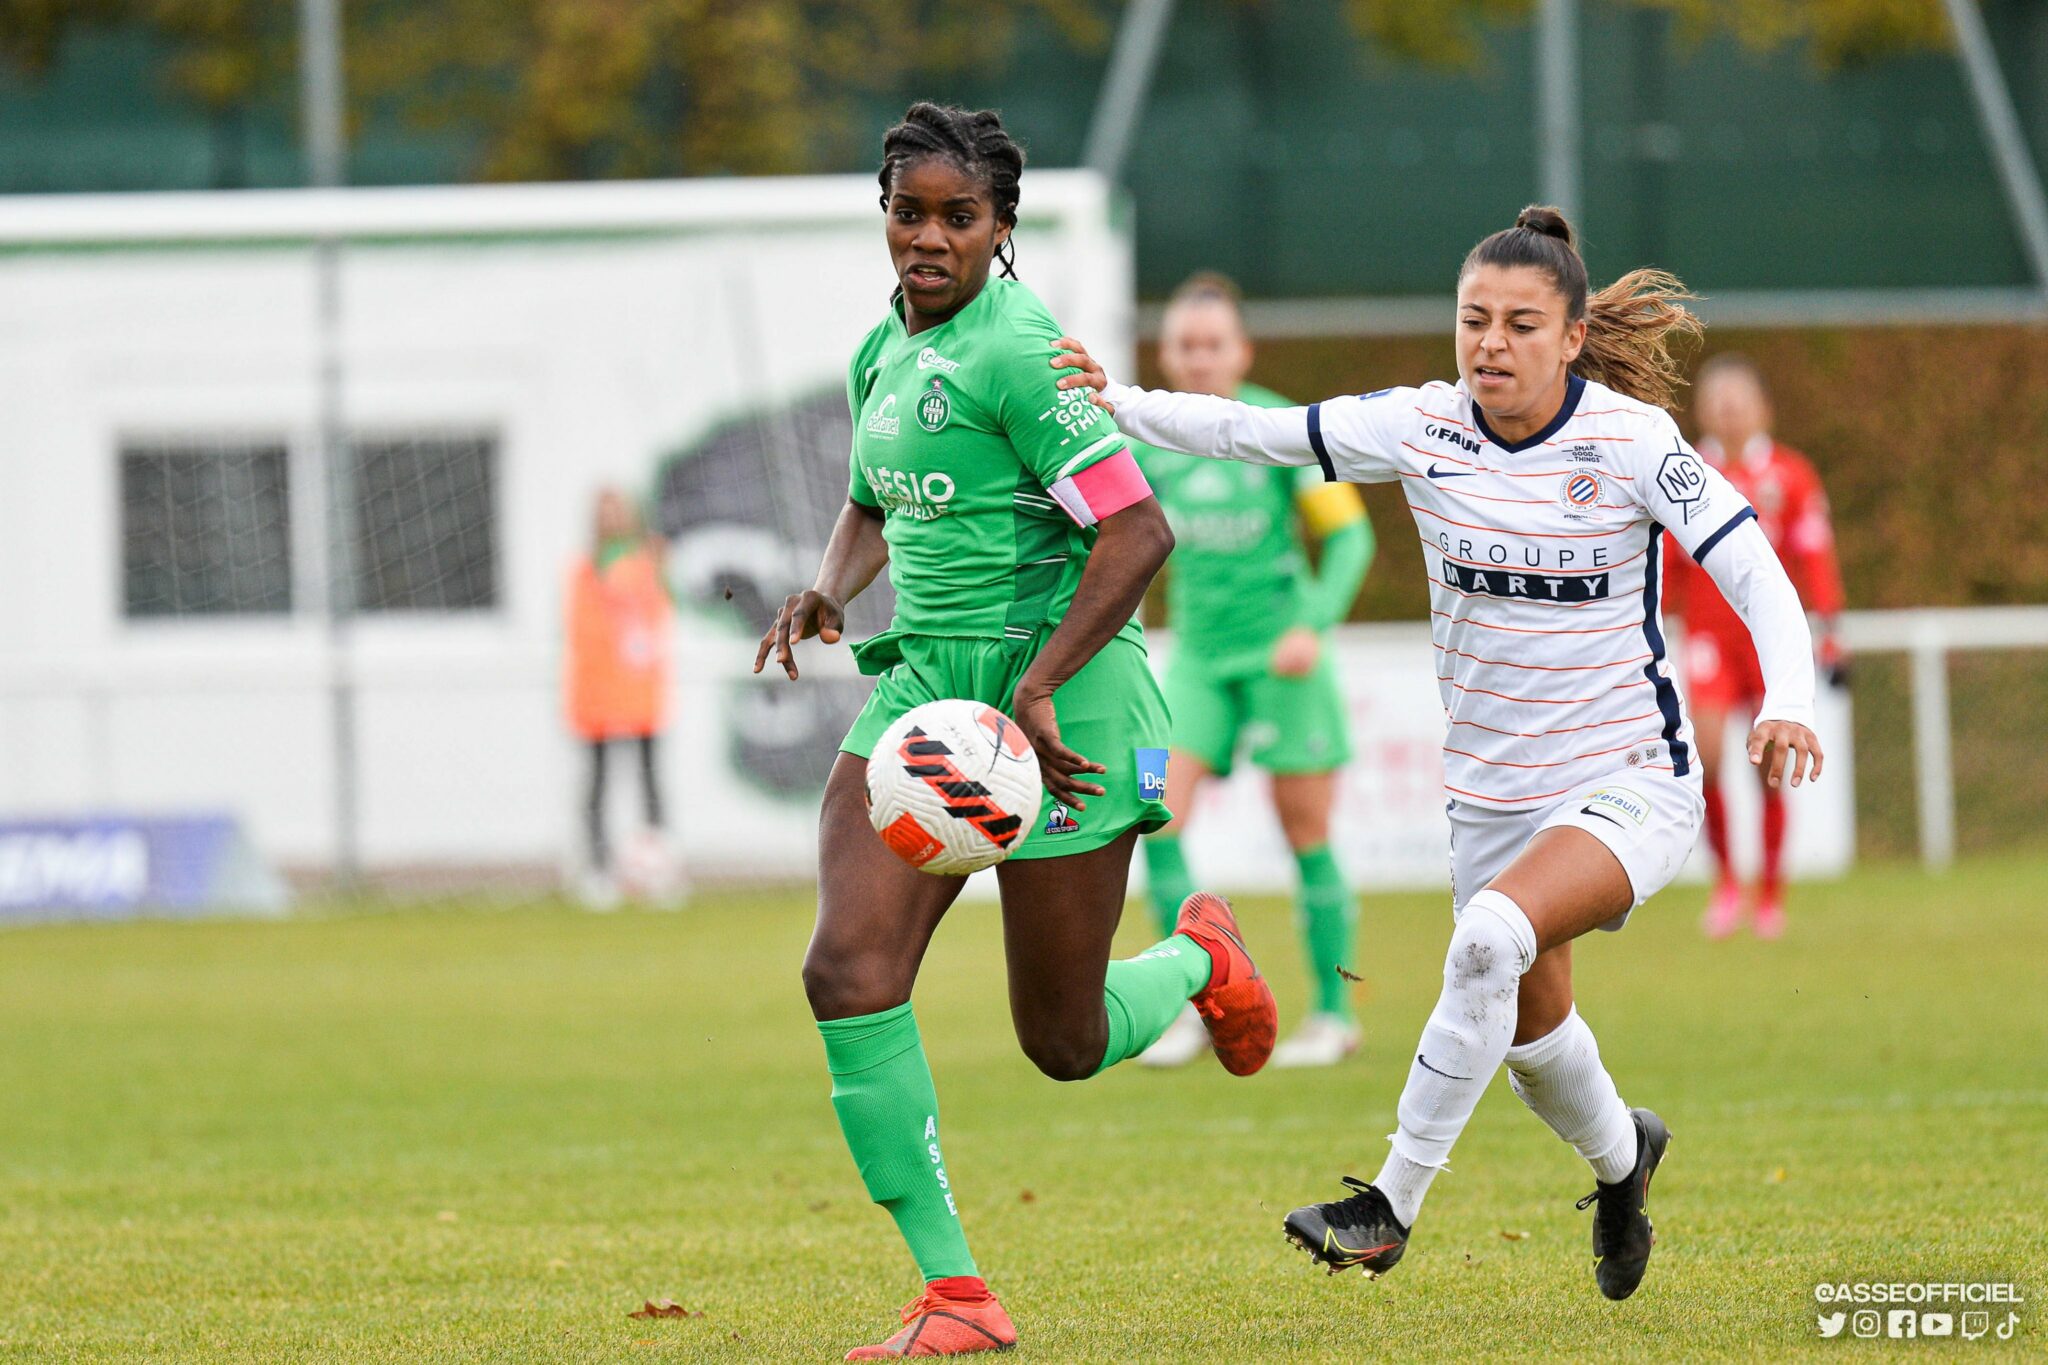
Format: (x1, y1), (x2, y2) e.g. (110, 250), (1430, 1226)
(0, 0), (1948, 180)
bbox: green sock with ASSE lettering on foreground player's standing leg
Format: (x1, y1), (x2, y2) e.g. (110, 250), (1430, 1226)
(817, 1001), (981, 1279)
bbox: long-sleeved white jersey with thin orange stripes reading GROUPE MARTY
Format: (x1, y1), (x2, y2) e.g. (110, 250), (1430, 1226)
(1104, 377), (1812, 810)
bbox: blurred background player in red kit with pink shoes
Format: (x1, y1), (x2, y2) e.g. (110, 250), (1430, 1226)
(1665, 354), (1841, 939)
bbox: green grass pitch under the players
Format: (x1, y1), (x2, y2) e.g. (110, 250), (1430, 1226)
(0, 857), (2048, 1361)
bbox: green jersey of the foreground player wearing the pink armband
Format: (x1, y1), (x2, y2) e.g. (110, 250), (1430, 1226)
(846, 278), (1137, 641)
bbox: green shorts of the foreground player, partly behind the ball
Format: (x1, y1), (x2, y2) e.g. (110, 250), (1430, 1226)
(840, 626), (1174, 857)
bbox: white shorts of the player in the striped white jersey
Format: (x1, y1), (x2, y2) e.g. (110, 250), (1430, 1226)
(1448, 767), (1706, 929)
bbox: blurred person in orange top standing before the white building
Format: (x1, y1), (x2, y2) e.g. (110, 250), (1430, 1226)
(563, 489), (674, 909)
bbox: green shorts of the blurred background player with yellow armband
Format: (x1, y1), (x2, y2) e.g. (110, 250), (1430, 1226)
(1165, 643), (1352, 776)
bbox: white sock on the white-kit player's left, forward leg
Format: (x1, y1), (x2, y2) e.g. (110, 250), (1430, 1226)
(1372, 890), (1536, 1226)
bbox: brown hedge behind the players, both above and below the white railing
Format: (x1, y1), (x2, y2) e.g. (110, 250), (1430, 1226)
(1145, 321), (2048, 857)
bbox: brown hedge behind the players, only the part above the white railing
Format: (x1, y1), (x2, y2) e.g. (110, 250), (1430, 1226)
(1145, 319), (2048, 620)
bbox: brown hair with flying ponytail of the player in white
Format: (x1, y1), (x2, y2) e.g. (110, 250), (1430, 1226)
(1458, 205), (1702, 407)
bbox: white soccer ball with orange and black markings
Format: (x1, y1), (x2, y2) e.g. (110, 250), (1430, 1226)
(868, 698), (1040, 876)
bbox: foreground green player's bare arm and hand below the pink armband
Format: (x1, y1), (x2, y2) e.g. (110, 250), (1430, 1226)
(1010, 493), (1174, 810)
